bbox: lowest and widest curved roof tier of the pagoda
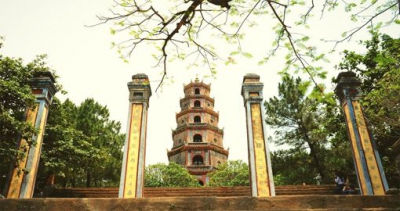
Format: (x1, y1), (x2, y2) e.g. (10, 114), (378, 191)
(167, 142), (229, 157)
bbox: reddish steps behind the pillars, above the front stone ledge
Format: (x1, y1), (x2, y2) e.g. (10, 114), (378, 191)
(50, 185), (335, 198)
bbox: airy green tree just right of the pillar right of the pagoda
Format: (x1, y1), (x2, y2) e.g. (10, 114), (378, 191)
(264, 76), (328, 178)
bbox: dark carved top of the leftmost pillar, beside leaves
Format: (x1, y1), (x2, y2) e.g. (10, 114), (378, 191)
(30, 71), (57, 104)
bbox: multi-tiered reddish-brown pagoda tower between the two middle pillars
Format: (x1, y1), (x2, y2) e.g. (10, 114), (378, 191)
(168, 78), (229, 185)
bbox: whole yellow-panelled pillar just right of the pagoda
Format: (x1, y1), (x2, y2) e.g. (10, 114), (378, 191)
(242, 74), (275, 197)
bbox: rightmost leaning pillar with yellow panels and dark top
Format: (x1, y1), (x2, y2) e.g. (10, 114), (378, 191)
(335, 72), (388, 195)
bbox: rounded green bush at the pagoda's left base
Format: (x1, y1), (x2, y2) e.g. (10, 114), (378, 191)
(144, 162), (200, 187)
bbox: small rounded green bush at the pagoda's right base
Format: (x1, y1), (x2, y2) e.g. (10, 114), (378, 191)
(207, 160), (250, 187)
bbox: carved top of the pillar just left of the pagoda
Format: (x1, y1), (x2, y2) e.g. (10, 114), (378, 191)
(128, 73), (151, 107)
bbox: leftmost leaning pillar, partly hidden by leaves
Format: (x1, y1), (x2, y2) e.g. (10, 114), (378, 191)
(6, 72), (57, 198)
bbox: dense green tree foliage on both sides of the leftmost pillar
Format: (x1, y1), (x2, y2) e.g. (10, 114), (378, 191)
(0, 38), (124, 188)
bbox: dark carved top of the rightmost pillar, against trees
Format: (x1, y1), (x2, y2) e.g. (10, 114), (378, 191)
(335, 72), (361, 102)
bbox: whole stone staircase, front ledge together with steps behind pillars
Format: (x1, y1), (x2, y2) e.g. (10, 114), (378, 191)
(0, 185), (400, 211)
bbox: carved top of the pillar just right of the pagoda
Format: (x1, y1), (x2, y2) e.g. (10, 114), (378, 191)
(242, 73), (264, 106)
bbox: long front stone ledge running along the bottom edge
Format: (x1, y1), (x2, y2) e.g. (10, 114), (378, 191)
(0, 195), (400, 211)
